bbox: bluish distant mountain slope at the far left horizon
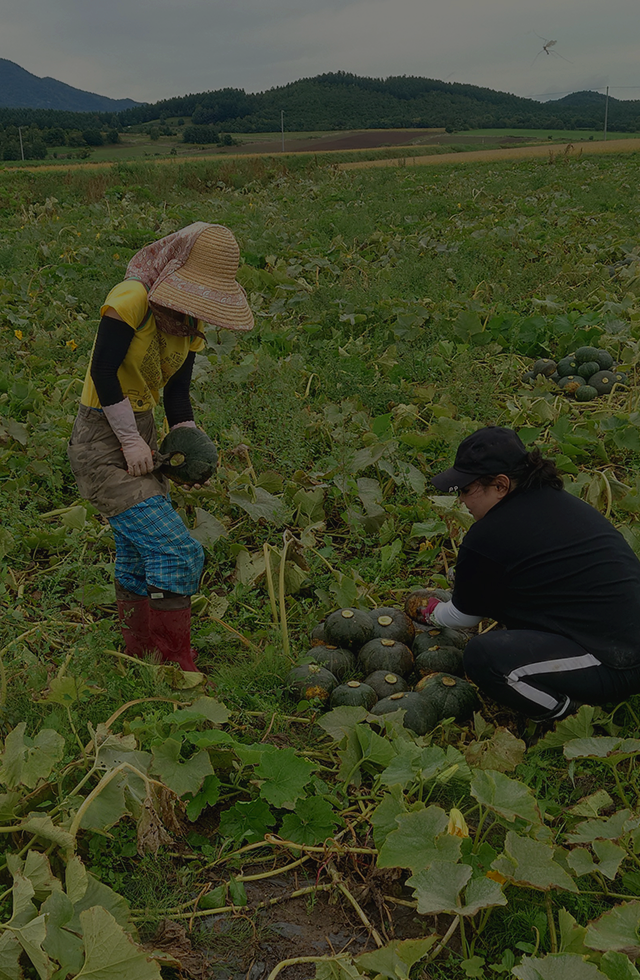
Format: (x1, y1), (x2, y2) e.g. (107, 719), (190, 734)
(0, 58), (142, 112)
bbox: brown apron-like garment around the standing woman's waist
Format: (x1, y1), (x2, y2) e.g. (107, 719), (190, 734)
(67, 405), (169, 517)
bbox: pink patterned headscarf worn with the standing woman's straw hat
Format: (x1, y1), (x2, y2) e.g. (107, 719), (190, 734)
(125, 221), (209, 337)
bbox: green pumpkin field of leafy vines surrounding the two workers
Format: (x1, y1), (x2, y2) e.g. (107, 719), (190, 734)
(0, 147), (640, 980)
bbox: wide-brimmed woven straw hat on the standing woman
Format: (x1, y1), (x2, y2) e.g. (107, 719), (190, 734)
(149, 225), (253, 330)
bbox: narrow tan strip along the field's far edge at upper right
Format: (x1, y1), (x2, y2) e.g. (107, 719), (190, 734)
(338, 139), (640, 170)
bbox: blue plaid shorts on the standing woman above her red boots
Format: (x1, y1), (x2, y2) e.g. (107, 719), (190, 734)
(109, 495), (204, 595)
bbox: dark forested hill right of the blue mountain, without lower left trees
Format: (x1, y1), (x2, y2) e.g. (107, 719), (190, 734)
(120, 72), (640, 132)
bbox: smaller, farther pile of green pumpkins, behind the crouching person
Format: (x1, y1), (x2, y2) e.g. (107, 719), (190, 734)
(522, 347), (628, 402)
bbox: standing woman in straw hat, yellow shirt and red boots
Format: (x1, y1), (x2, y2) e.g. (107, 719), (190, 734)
(68, 221), (253, 671)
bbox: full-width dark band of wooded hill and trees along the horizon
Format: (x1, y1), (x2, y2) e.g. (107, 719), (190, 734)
(0, 72), (640, 160)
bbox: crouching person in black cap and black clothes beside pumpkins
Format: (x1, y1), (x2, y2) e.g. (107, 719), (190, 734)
(418, 426), (640, 721)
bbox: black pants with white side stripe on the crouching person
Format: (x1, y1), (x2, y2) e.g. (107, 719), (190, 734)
(464, 630), (640, 720)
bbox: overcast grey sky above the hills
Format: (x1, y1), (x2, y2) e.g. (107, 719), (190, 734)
(5, 0), (640, 102)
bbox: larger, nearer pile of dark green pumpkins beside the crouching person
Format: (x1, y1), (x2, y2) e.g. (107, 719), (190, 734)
(286, 592), (477, 735)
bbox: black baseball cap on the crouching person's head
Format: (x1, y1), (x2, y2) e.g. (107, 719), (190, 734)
(431, 425), (527, 493)
